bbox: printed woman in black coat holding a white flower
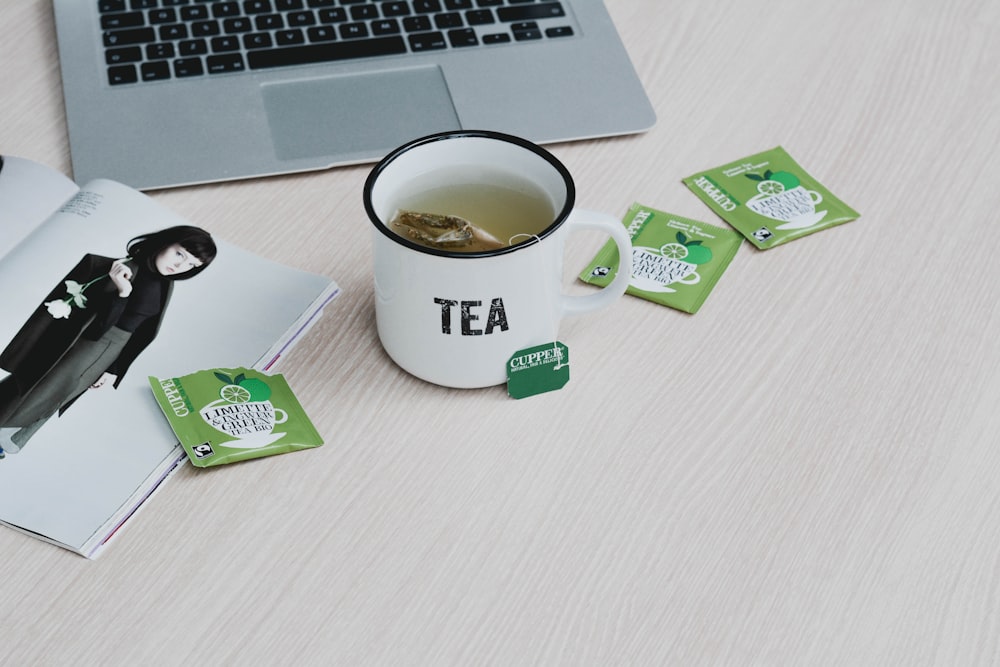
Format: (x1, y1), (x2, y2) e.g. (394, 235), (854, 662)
(0, 225), (216, 459)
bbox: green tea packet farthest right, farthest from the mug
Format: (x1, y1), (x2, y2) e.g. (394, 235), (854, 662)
(683, 146), (859, 250)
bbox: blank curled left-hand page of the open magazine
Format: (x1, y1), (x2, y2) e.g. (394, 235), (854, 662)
(0, 155), (79, 257)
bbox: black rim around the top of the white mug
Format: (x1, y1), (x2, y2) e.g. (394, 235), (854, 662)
(364, 130), (576, 259)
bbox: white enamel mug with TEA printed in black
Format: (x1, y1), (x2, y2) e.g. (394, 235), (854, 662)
(364, 131), (632, 388)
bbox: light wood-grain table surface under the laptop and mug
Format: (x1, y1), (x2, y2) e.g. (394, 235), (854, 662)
(0, 0), (1000, 665)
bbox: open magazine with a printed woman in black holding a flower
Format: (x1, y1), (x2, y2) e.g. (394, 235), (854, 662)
(0, 156), (339, 558)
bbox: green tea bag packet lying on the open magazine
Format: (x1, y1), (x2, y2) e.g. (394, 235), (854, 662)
(149, 368), (323, 468)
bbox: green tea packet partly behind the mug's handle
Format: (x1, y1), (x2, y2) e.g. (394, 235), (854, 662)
(580, 204), (743, 313)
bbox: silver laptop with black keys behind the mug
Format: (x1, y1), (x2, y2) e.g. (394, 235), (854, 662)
(53, 0), (655, 189)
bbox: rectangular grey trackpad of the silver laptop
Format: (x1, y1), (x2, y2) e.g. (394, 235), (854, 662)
(261, 67), (461, 160)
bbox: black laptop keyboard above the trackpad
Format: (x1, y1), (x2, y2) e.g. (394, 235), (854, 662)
(100, 0), (573, 85)
